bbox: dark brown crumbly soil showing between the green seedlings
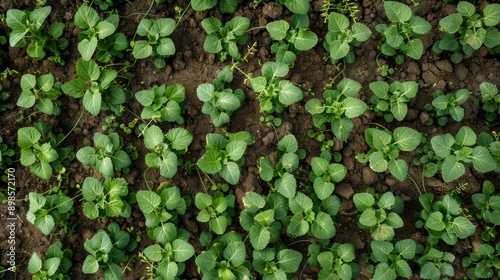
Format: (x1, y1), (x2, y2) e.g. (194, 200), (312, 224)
(0, 0), (500, 279)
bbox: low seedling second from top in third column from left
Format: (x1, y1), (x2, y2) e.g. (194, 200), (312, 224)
(135, 84), (186, 124)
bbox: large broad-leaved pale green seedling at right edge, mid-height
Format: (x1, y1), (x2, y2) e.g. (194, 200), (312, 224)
(431, 126), (498, 182)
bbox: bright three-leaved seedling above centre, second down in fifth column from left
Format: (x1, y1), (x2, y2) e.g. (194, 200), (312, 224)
(250, 61), (304, 114)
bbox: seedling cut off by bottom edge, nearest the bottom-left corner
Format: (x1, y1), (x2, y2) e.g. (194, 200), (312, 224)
(28, 241), (73, 280)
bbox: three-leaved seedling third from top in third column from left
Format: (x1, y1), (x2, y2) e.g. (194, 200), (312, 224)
(144, 125), (193, 179)
